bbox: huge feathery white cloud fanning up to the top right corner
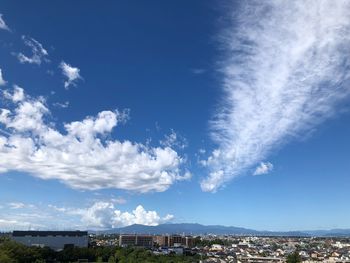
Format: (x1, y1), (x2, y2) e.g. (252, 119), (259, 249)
(201, 0), (350, 192)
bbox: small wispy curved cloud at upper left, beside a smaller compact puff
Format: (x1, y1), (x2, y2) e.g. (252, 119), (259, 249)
(17, 36), (49, 65)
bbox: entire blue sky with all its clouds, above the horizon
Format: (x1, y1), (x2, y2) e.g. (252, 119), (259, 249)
(0, 0), (350, 230)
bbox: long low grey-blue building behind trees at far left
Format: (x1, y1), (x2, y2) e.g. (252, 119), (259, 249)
(11, 231), (89, 250)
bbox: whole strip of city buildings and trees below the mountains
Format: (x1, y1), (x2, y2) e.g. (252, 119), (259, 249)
(0, 231), (350, 263)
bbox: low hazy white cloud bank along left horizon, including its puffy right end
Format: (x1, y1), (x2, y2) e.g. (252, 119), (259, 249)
(0, 199), (174, 231)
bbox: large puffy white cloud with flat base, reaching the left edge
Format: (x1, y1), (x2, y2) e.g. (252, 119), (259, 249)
(0, 87), (190, 193)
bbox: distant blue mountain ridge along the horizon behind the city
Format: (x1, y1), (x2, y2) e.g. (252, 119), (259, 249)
(95, 223), (350, 237)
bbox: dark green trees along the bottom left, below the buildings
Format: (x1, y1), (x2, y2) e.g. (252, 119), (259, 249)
(0, 240), (200, 263)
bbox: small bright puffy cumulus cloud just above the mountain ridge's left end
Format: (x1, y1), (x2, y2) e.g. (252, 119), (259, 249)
(78, 201), (174, 228)
